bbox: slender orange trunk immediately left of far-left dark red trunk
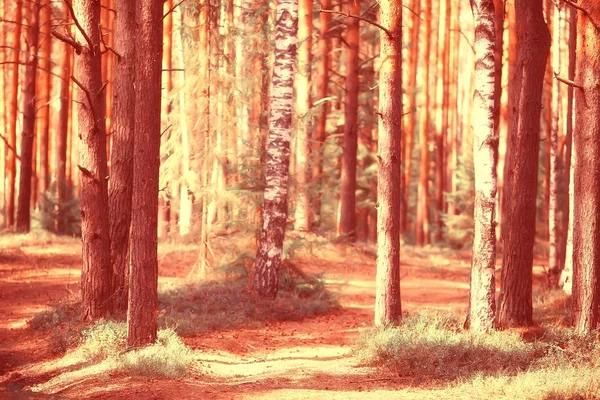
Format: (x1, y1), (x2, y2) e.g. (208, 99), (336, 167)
(6, 0), (23, 229)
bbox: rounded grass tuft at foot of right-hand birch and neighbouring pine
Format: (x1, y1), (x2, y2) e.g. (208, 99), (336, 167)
(355, 313), (536, 380)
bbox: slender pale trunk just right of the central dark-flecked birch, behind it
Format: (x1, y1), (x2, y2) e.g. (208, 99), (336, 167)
(294, 0), (313, 231)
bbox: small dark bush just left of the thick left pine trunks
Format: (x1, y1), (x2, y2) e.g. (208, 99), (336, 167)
(33, 183), (81, 236)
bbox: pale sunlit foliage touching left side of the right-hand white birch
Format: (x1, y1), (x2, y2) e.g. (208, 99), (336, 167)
(442, 144), (475, 249)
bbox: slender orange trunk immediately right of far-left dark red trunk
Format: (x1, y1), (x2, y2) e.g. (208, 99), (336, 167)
(36, 2), (52, 205)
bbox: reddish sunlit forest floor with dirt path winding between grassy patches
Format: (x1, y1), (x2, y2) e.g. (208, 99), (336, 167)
(0, 235), (556, 400)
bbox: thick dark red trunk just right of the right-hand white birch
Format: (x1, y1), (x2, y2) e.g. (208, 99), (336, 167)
(498, 0), (550, 326)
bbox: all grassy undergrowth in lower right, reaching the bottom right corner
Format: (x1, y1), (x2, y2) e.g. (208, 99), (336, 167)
(354, 310), (600, 399)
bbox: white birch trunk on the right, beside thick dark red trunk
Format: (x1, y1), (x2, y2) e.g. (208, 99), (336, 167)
(469, 0), (498, 332)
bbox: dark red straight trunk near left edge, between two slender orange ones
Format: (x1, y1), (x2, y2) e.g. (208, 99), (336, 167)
(16, 1), (40, 233)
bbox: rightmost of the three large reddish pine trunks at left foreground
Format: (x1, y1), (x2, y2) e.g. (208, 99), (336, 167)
(127, 0), (163, 347)
